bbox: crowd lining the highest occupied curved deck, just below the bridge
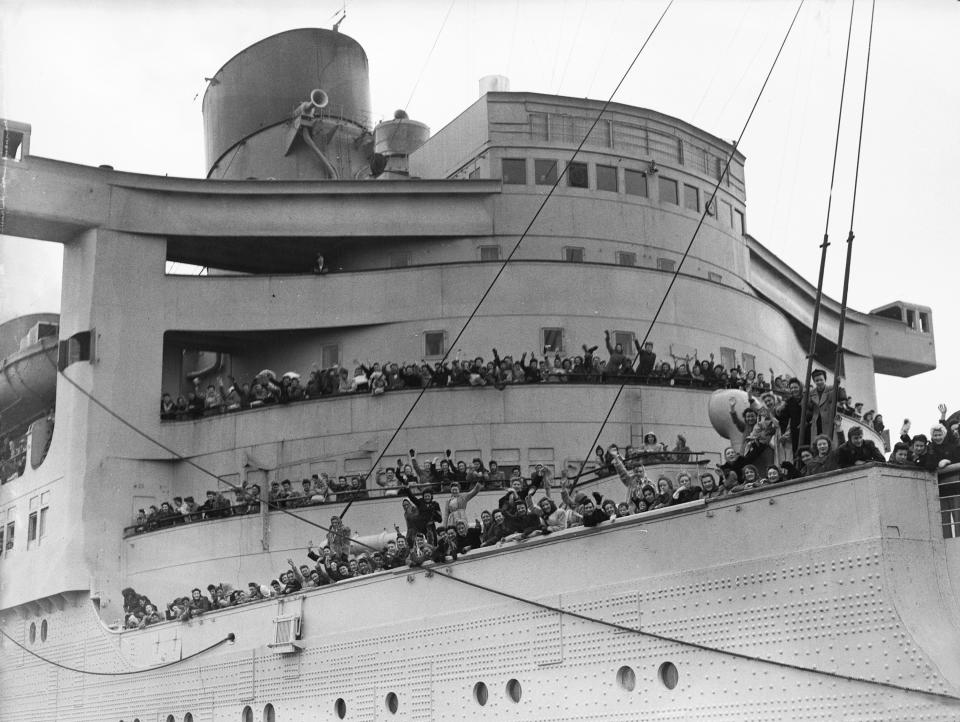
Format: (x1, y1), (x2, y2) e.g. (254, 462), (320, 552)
(160, 331), (832, 421)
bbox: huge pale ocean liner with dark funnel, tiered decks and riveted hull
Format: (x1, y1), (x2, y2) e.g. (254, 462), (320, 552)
(0, 15), (960, 722)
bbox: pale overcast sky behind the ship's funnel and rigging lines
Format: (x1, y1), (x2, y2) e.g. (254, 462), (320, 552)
(0, 0), (960, 429)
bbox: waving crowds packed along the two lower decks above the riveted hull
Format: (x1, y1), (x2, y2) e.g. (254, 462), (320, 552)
(123, 399), (960, 628)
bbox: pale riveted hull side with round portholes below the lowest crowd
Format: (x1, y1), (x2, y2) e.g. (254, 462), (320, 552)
(0, 466), (960, 722)
